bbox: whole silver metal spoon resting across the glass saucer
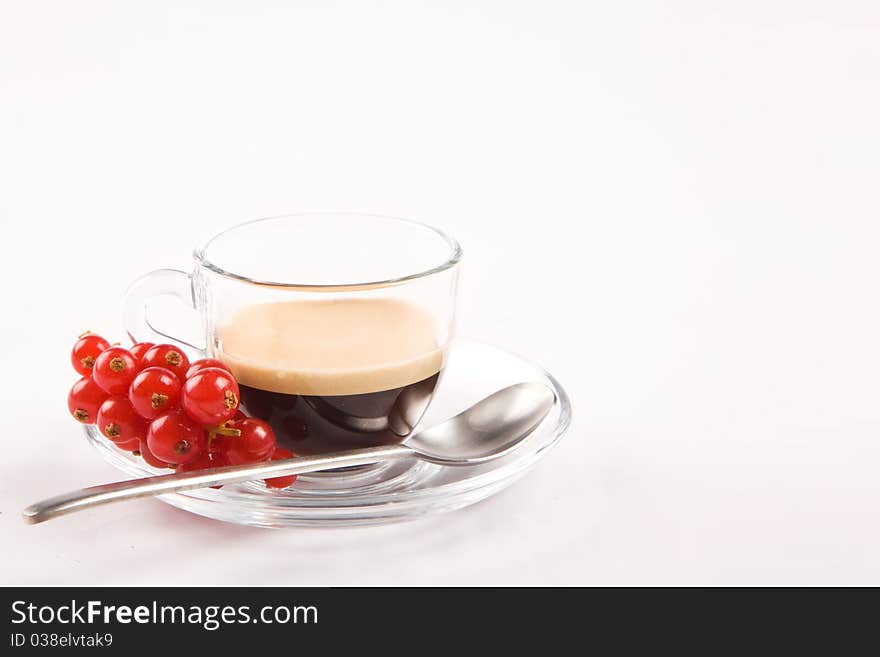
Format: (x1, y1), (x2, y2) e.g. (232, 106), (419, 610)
(23, 383), (556, 524)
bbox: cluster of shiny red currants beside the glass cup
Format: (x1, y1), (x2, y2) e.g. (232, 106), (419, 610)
(67, 333), (296, 488)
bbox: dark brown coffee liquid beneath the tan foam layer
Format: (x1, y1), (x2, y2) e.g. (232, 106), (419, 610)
(239, 373), (440, 454)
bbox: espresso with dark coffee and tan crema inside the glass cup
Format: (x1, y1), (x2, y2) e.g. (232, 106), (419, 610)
(214, 298), (443, 454)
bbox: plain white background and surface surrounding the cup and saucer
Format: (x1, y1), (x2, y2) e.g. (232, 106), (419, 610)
(0, 0), (880, 584)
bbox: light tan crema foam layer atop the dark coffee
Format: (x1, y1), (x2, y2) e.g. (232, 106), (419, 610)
(215, 299), (443, 396)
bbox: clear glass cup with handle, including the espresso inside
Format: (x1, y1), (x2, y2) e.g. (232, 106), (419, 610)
(123, 213), (462, 454)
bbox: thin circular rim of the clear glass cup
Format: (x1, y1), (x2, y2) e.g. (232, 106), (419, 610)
(193, 212), (463, 291)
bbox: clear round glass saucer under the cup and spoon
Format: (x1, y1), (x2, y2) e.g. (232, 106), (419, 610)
(85, 341), (571, 527)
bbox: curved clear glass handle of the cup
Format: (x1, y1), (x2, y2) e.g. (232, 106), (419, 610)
(122, 269), (205, 353)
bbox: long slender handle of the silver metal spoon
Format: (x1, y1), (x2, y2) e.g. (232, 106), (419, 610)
(23, 445), (416, 524)
